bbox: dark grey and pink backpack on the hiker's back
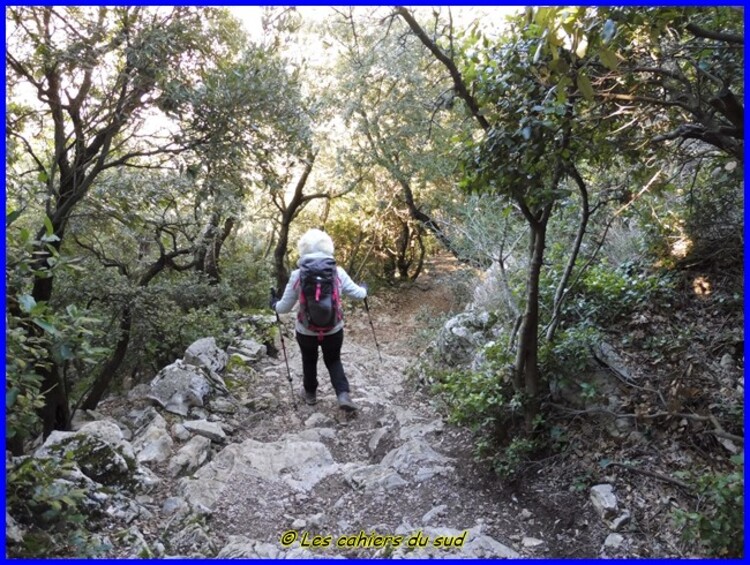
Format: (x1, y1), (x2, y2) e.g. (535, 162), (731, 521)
(297, 257), (343, 336)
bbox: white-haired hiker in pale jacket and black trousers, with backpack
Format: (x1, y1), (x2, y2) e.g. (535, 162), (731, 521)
(270, 229), (367, 412)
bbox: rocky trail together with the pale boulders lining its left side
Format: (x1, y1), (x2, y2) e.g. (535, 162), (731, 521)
(10, 263), (640, 558)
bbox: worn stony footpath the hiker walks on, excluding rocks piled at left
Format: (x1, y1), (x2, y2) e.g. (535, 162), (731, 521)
(197, 261), (606, 557)
